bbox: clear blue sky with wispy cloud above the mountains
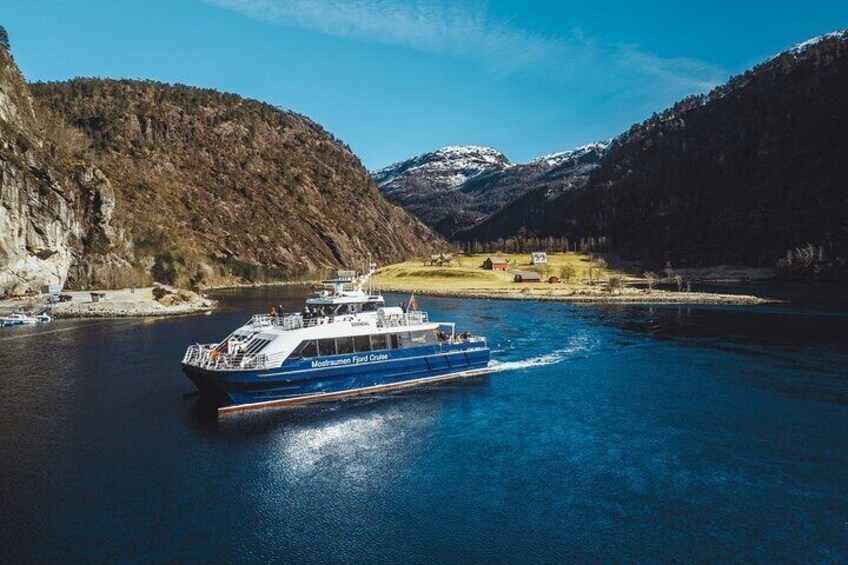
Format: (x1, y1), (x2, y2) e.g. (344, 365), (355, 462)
(0, 0), (848, 170)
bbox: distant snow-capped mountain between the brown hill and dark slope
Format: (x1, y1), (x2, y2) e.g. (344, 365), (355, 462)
(373, 143), (606, 237)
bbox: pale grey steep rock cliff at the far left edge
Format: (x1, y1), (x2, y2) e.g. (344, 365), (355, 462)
(0, 48), (121, 293)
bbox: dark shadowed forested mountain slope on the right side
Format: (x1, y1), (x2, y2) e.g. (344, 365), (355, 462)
(463, 32), (848, 272)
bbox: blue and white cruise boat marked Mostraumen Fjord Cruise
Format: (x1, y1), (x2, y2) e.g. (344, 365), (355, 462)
(182, 263), (489, 414)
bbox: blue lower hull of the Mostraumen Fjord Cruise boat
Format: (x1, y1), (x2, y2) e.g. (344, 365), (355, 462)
(183, 345), (489, 413)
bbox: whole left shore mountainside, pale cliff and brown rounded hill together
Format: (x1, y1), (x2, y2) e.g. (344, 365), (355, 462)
(0, 41), (440, 292)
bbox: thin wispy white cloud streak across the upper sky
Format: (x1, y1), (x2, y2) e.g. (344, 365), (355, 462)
(206, 0), (727, 92)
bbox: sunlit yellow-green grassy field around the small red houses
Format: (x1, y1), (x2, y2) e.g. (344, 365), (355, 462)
(374, 253), (612, 291)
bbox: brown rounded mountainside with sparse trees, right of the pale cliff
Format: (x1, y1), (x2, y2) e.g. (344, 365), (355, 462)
(22, 79), (437, 284)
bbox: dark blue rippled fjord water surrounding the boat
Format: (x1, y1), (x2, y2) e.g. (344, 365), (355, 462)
(0, 287), (848, 563)
